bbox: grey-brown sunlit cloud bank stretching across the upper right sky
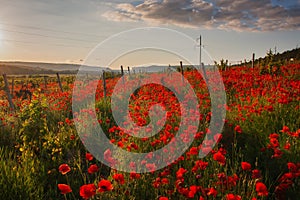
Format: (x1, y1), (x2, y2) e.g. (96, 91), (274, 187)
(103, 0), (300, 31)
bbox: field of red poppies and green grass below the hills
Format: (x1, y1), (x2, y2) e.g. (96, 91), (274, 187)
(0, 64), (300, 200)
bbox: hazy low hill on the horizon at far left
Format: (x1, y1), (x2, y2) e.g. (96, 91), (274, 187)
(0, 61), (111, 75)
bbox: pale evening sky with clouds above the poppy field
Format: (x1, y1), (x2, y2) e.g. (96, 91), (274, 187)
(0, 0), (300, 68)
